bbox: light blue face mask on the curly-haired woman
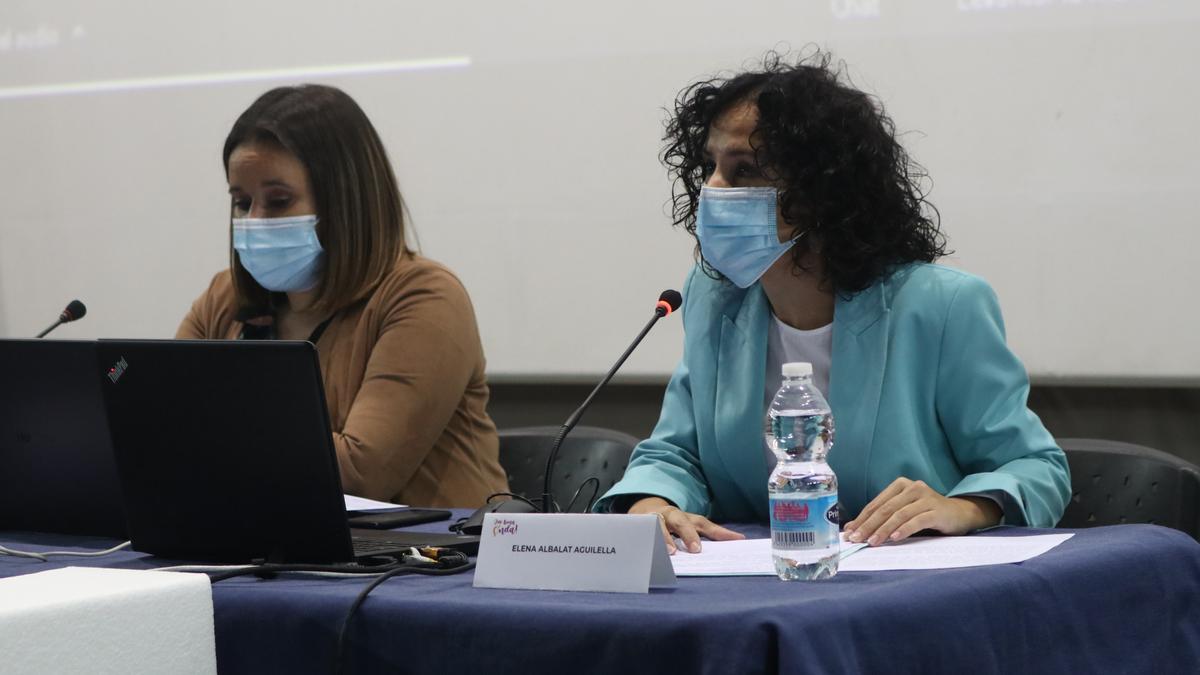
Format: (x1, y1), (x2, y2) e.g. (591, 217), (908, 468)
(696, 186), (799, 288)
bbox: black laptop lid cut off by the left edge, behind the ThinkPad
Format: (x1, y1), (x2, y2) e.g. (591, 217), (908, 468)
(0, 340), (127, 540)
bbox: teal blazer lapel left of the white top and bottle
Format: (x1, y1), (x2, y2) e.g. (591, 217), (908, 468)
(713, 285), (770, 518)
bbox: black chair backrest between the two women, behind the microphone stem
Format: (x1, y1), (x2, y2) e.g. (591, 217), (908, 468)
(500, 426), (637, 513)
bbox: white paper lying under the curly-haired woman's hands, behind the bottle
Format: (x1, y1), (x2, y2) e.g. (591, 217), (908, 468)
(671, 533), (1072, 577)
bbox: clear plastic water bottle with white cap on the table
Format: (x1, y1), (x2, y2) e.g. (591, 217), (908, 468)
(766, 363), (841, 580)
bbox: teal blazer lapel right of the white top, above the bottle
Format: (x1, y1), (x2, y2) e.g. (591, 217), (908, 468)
(829, 283), (889, 518)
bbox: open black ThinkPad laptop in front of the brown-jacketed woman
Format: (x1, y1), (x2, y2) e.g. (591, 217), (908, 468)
(96, 340), (479, 563)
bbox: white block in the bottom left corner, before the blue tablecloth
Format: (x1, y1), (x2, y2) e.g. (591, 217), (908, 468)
(0, 567), (217, 675)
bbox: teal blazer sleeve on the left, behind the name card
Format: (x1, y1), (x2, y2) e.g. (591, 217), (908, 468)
(593, 270), (712, 515)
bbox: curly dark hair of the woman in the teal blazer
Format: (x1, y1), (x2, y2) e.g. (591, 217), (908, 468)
(662, 50), (947, 297)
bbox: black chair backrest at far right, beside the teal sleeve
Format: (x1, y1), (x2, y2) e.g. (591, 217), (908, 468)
(1058, 438), (1200, 540)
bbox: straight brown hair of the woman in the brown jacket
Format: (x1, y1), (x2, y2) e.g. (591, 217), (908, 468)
(222, 84), (410, 315)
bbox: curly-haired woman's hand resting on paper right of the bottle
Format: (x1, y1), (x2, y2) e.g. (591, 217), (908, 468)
(844, 477), (1003, 546)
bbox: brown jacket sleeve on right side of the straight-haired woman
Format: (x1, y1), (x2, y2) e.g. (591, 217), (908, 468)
(334, 271), (482, 501)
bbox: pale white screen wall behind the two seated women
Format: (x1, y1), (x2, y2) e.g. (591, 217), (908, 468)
(0, 0), (1200, 381)
